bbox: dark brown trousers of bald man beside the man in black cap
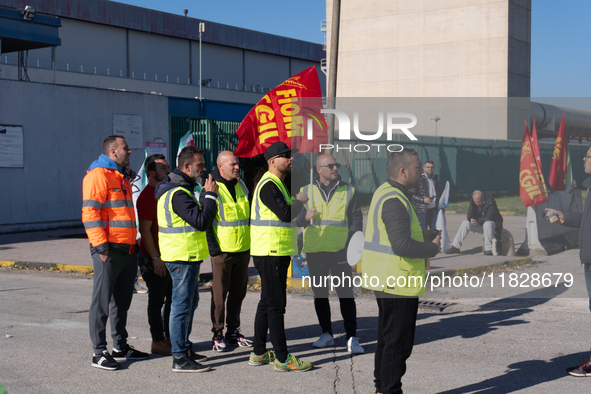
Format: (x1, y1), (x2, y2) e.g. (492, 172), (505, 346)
(211, 251), (250, 334)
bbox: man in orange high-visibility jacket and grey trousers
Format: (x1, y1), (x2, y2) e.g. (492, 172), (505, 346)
(82, 135), (148, 371)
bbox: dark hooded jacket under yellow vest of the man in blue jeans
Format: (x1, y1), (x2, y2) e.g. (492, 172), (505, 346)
(156, 168), (217, 262)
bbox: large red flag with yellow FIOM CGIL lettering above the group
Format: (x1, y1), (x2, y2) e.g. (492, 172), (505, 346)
(234, 66), (328, 157)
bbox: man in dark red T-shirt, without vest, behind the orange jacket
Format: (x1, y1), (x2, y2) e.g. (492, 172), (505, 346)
(136, 153), (172, 356)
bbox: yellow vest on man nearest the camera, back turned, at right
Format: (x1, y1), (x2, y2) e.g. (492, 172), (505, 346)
(362, 182), (425, 296)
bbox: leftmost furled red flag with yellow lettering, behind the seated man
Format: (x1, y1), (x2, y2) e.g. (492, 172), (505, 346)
(519, 123), (548, 208)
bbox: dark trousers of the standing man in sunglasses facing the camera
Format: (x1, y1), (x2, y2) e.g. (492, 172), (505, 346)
(306, 253), (357, 340)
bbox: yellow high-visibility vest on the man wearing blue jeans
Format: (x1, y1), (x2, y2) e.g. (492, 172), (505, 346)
(157, 186), (209, 262)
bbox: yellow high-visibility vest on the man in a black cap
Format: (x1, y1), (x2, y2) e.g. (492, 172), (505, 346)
(250, 172), (297, 256)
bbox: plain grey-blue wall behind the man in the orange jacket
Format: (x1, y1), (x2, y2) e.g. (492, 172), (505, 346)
(0, 79), (168, 231)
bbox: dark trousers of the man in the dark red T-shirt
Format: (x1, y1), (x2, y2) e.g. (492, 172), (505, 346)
(138, 253), (172, 342)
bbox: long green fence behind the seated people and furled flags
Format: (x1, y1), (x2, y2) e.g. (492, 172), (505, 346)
(296, 135), (589, 196)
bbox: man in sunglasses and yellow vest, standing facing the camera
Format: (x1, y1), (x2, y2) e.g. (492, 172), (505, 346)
(298, 154), (364, 354)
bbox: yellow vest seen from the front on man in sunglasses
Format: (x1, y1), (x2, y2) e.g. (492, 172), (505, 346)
(302, 184), (354, 253)
